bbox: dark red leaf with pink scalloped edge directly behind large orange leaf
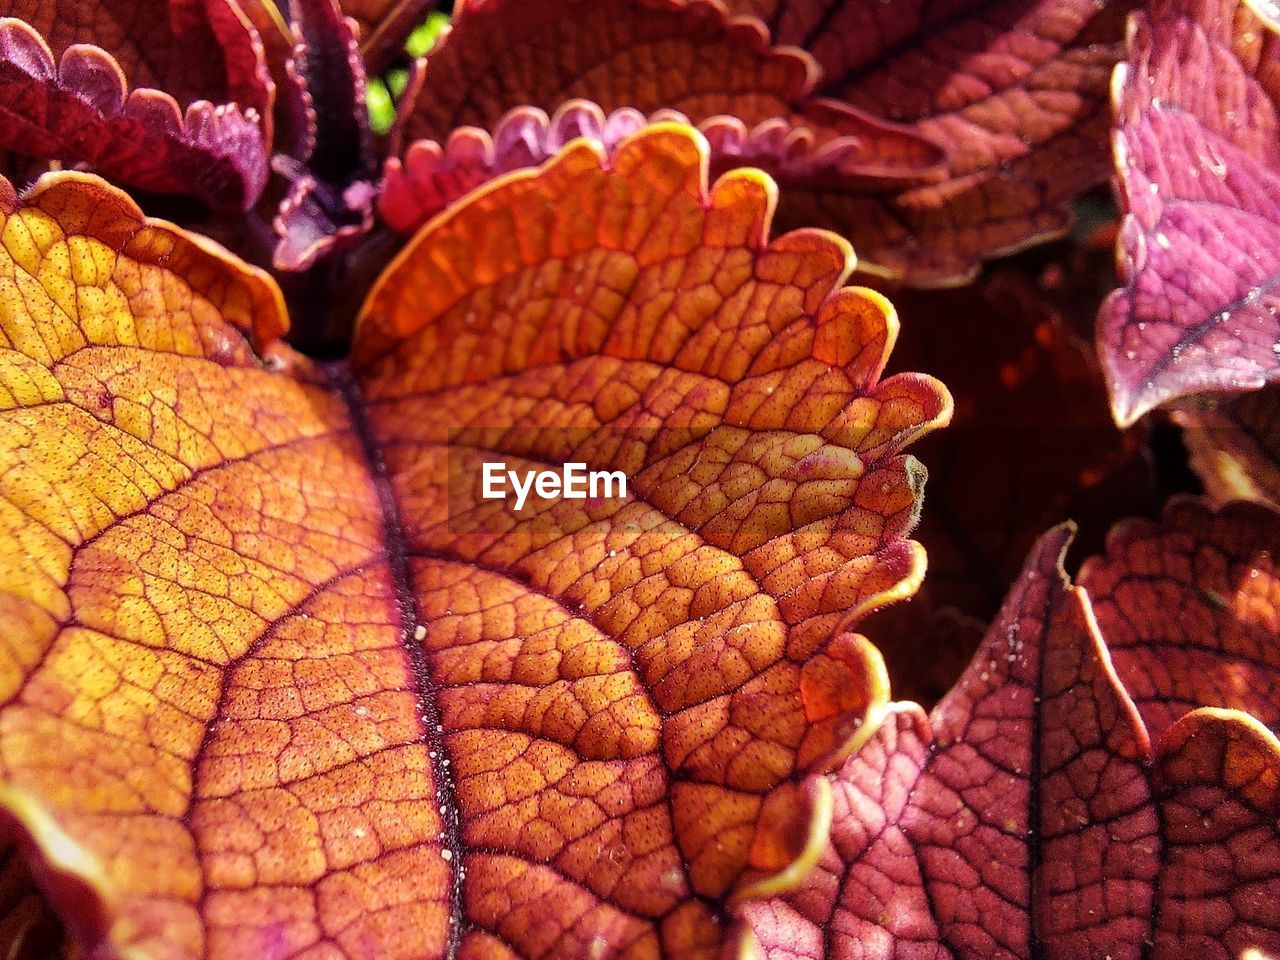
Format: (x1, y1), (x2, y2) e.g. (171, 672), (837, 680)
(392, 0), (943, 223)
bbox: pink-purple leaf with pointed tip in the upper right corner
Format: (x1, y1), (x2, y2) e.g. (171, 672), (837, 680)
(1098, 0), (1280, 424)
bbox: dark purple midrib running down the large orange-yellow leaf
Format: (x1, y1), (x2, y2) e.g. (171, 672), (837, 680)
(323, 361), (463, 960)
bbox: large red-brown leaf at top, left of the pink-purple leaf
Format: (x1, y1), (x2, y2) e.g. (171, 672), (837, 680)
(726, 0), (1134, 285)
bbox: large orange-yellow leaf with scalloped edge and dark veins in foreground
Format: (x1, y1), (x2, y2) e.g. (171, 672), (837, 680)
(0, 125), (950, 957)
